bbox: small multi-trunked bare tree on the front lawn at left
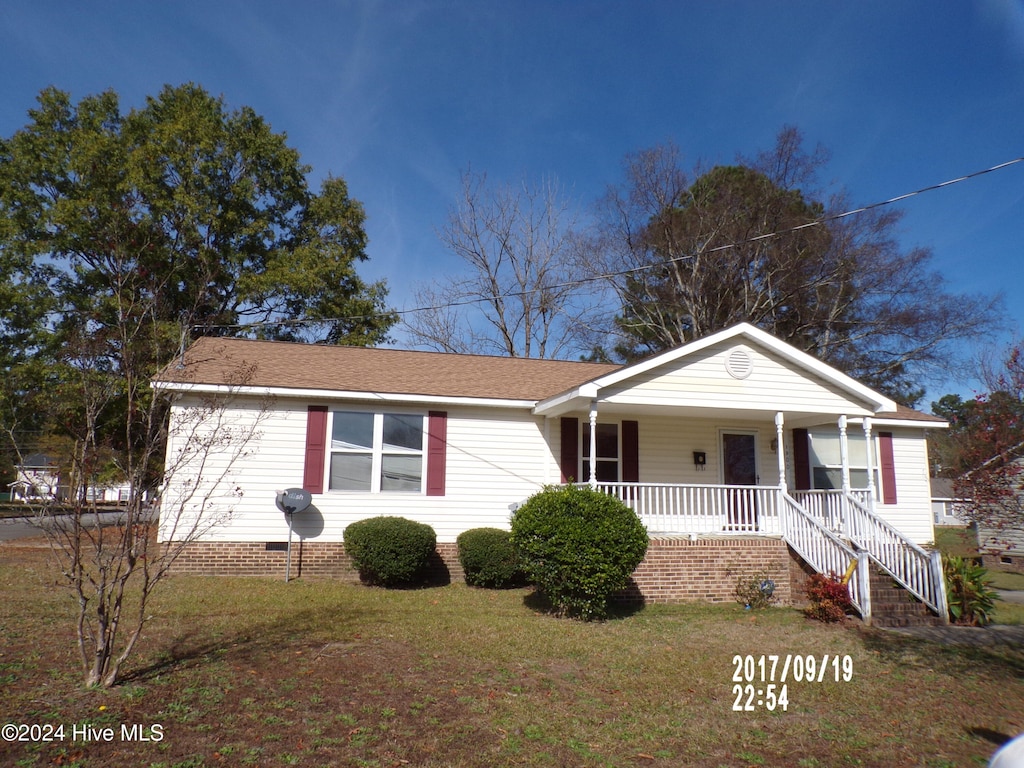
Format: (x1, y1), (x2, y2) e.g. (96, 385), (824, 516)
(8, 331), (268, 687)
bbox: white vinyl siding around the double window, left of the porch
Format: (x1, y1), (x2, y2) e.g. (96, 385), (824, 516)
(161, 398), (557, 542)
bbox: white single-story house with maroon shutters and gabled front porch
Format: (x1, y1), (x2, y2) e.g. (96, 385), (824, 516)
(154, 324), (946, 616)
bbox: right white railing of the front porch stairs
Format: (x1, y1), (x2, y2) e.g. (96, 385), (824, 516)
(844, 496), (949, 623)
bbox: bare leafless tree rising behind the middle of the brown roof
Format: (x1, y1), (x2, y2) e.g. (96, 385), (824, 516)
(406, 172), (592, 357)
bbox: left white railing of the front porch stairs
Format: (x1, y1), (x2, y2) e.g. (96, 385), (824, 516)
(778, 490), (871, 624)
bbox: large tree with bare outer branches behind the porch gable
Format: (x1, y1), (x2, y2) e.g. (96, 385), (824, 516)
(590, 128), (996, 403)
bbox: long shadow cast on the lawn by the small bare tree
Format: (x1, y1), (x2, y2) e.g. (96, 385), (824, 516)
(118, 605), (370, 685)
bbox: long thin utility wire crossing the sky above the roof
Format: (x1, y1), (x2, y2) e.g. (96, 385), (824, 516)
(195, 157), (1024, 329)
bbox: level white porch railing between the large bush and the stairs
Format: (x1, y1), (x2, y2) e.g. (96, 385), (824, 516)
(593, 482), (782, 535)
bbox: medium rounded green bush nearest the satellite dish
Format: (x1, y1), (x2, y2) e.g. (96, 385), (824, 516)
(345, 517), (437, 587)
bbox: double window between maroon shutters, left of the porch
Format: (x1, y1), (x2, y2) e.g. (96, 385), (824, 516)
(329, 411), (424, 494)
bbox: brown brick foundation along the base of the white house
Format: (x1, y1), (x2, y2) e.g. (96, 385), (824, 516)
(163, 536), (806, 605)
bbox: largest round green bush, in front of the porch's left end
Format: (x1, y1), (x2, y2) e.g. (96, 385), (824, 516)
(512, 485), (647, 621)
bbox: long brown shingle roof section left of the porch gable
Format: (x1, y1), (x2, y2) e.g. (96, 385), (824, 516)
(150, 338), (620, 400)
